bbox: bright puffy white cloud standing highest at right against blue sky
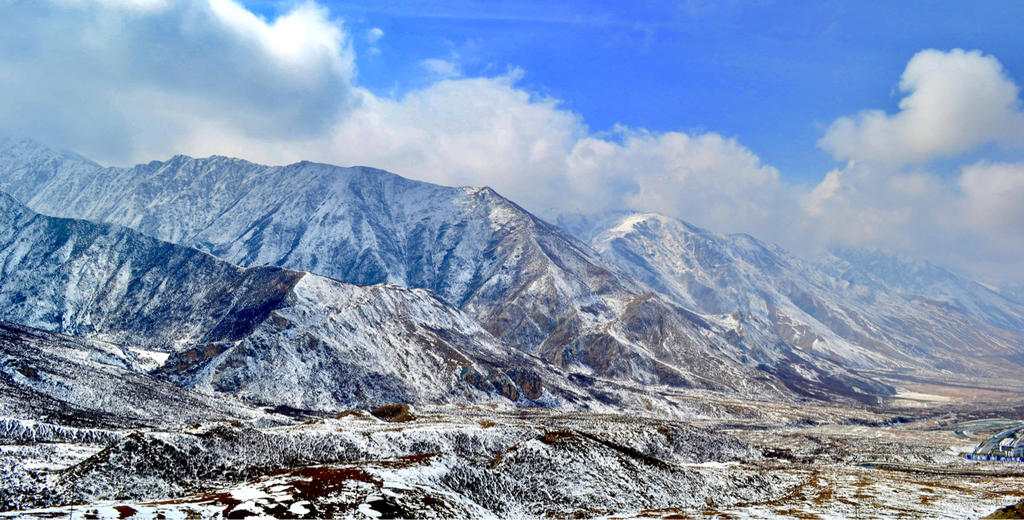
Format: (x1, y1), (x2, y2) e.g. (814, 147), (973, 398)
(818, 49), (1024, 165)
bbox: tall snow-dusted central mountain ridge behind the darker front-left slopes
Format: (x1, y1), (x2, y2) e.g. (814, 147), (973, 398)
(0, 141), (815, 395)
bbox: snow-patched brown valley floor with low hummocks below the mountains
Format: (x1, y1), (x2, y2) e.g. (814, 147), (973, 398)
(0, 388), (1024, 519)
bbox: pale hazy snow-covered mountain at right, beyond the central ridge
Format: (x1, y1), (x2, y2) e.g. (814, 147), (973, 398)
(592, 214), (1024, 375)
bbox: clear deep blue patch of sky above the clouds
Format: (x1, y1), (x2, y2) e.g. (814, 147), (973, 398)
(249, 0), (1024, 183)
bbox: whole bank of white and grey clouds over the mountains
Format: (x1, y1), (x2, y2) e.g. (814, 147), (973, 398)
(0, 0), (1024, 278)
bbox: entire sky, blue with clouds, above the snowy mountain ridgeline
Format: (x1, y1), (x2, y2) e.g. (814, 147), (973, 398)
(0, 0), (1024, 284)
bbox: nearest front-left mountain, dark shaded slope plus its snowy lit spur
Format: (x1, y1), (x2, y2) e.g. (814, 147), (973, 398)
(0, 193), (593, 408)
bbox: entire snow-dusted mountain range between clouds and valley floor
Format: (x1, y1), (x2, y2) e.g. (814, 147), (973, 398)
(0, 139), (1024, 409)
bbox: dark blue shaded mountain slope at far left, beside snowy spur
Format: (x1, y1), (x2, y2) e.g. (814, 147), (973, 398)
(0, 193), (302, 352)
